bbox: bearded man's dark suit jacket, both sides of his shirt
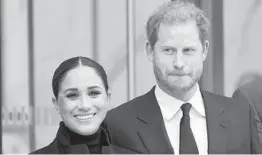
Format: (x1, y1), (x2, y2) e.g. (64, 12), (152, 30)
(107, 88), (262, 154)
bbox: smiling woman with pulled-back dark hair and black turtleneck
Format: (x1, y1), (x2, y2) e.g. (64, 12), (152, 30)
(30, 57), (131, 154)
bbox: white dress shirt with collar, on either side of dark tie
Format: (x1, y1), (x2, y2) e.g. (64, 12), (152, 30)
(155, 85), (208, 154)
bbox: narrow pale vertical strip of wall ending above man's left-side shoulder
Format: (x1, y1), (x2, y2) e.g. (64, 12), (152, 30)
(127, 0), (136, 100)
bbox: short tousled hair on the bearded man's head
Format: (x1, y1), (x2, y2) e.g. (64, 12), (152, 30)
(146, 0), (209, 48)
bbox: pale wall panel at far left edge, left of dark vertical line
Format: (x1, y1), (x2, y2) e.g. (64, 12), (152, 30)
(1, 0), (30, 153)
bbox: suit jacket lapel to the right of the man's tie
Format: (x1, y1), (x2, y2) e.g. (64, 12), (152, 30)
(201, 91), (228, 154)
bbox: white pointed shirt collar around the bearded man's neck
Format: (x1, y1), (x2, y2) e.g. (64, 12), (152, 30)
(155, 84), (206, 121)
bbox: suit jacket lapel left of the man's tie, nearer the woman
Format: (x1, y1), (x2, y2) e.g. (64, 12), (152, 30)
(137, 88), (174, 154)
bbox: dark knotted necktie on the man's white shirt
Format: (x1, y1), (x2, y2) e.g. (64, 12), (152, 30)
(179, 103), (198, 154)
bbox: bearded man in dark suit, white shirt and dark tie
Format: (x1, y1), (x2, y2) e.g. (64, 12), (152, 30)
(107, 1), (262, 154)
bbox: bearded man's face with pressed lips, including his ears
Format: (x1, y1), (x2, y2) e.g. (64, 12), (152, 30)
(147, 20), (208, 92)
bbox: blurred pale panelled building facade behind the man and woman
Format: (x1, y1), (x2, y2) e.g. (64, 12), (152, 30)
(1, 0), (262, 153)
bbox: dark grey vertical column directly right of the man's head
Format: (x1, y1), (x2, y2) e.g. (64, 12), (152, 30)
(200, 0), (224, 95)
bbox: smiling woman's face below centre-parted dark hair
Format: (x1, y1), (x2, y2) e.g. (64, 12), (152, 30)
(53, 66), (109, 135)
